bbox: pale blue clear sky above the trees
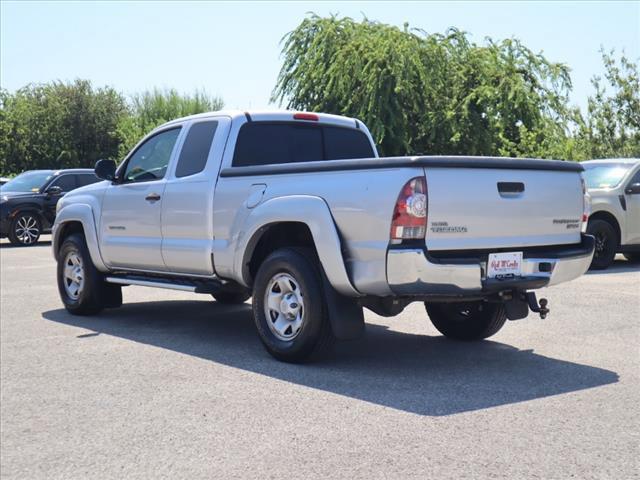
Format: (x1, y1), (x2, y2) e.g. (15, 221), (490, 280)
(0, 0), (640, 110)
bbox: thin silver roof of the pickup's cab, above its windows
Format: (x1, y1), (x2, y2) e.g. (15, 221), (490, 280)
(159, 110), (361, 128)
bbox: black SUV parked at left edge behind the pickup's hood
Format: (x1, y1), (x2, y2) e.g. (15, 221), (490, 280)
(0, 168), (100, 245)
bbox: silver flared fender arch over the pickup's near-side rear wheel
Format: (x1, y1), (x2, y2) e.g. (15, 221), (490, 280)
(234, 195), (361, 297)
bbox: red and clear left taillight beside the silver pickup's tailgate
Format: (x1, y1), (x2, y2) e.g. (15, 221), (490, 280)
(391, 177), (427, 243)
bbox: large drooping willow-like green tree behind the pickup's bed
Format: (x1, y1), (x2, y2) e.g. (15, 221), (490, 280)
(272, 15), (572, 156)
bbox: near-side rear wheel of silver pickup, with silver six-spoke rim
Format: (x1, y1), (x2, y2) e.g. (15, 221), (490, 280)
(253, 248), (334, 363)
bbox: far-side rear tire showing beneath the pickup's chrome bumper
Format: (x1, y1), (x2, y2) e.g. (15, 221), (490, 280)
(425, 301), (507, 341)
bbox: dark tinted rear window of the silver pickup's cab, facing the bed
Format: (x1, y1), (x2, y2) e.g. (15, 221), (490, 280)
(233, 122), (374, 167)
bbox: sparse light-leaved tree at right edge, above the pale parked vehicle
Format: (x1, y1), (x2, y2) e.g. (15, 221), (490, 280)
(577, 50), (640, 159)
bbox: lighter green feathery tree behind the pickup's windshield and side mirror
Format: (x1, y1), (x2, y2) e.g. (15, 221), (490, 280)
(118, 89), (224, 158)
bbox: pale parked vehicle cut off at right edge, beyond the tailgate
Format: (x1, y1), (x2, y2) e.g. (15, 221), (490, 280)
(582, 158), (640, 269)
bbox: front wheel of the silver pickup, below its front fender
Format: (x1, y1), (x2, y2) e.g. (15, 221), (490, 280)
(57, 233), (122, 315)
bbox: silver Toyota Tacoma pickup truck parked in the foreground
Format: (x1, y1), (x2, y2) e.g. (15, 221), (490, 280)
(53, 112), (594, 362)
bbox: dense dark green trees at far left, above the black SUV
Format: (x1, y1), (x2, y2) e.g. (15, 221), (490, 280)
(0, 80), (126, 174)
